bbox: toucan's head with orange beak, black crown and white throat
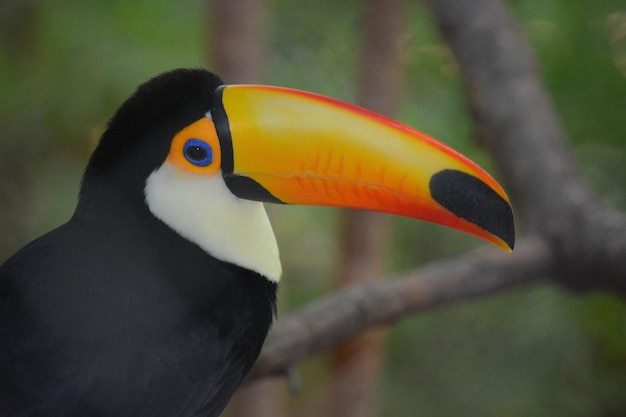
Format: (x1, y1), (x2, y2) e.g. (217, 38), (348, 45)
(79, 69), (515, 281)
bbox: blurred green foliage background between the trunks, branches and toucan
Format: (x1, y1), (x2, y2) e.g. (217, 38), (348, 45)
(0, 0), (626, 417)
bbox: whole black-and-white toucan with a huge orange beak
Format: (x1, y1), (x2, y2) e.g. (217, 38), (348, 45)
(0, 69), (515, 417)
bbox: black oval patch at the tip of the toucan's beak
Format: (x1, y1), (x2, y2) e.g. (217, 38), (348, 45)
(429, 169), (515, 250)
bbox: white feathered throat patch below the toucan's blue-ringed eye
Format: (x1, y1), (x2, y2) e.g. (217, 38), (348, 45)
(145, 163), (282, 282)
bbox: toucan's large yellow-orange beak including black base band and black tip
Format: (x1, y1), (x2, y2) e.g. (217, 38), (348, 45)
(211, 85), (515, 251)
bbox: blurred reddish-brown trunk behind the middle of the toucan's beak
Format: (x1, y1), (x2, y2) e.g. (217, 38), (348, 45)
(322, 0), (403, 417)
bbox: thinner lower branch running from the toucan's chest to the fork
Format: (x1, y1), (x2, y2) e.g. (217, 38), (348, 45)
(249, 239), (555, 378)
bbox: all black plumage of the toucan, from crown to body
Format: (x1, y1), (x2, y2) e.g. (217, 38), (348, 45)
(0, 70), (276, 417)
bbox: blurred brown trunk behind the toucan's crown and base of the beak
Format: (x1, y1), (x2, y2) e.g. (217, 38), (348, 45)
(209, 0), (284, 417)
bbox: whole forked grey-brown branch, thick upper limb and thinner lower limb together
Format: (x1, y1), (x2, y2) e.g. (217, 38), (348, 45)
(245, 0), (626, 378)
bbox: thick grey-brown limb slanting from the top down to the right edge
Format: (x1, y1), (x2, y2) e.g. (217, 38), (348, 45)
(429, 0), (626, 295)
